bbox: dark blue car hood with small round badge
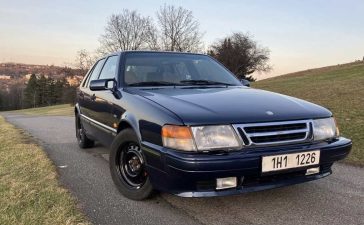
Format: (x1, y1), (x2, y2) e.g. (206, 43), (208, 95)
(126, 87), (332, 125)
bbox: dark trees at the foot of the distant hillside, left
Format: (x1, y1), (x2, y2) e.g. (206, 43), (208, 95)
(0, 74), (76, 111)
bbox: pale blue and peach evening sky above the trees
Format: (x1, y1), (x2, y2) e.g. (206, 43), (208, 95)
(0, 0), (364, 79)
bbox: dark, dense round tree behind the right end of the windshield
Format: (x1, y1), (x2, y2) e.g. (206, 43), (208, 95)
(208, 33), (271, 81)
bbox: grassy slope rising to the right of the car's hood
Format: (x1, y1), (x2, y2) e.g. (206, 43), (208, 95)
(253, 62), (364, 166)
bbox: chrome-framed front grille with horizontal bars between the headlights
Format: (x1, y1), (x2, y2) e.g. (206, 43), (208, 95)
(234, 120), (311, 145)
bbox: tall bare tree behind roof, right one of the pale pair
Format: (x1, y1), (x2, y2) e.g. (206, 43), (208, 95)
(157, 5), (203, 52)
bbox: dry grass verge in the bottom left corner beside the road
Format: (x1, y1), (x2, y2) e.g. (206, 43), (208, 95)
(0, 116), (88, 225)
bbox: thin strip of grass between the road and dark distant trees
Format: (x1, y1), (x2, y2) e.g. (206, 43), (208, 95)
(8, 104), (74, 116)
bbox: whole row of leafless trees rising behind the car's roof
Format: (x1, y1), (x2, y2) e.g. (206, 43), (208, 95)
(76, 4), (271, 81)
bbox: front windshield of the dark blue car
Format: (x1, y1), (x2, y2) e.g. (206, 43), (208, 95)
(124, 52), (241, 86)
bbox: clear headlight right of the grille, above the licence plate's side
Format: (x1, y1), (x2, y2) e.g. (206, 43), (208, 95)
(313, 117), (339, 141)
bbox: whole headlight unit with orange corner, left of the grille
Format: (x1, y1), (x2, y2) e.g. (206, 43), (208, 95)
(162, 125), (241, 151)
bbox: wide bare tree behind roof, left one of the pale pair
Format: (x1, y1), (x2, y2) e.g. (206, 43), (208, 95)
(99, 9), (157, 53)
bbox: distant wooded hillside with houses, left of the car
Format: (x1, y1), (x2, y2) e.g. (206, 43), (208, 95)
(0, 63), (85, 111)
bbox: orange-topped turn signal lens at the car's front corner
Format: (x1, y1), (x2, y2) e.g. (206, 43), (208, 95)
(162, 125), (196, 151)
